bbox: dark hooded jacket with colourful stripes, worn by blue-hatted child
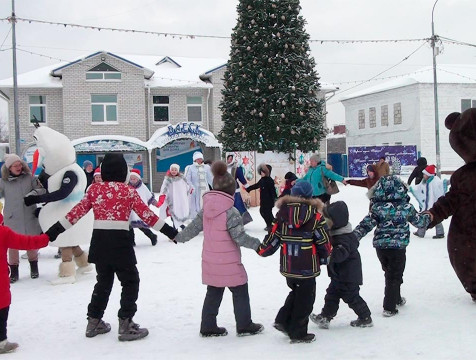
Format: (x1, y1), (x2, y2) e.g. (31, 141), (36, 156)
(258, 196), (331, 279)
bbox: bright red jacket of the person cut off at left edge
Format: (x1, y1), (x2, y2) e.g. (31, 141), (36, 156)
(0, 226), (50, 309)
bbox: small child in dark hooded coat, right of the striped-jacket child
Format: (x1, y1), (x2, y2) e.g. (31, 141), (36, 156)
(310, 201), (373, 329)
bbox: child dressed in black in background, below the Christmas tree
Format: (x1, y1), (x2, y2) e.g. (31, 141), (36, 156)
(246, 164), (276, 231)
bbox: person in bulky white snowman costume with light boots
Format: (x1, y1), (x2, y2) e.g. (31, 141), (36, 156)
(25, 126), (94, 284)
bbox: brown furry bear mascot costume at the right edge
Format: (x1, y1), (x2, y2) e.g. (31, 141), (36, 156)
(429, 108), (476, 302)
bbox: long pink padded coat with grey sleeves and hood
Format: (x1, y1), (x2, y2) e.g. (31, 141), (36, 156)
(175, 191), (260, 287)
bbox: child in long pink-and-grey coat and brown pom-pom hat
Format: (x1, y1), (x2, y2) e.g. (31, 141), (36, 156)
(174, 161), (264, 337)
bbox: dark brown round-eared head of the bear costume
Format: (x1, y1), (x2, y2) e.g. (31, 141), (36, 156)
(445, 108), (476, 163)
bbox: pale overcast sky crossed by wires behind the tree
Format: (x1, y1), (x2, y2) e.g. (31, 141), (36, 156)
(0, 0), (476, 123)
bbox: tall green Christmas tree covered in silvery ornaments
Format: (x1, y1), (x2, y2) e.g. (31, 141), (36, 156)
(218, 0), (326, 154)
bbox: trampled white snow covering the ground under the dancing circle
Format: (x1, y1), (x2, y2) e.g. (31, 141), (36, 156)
(8, 179), (476, 360)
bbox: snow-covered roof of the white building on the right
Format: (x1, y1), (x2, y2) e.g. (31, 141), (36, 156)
(340, 64), (476, 101)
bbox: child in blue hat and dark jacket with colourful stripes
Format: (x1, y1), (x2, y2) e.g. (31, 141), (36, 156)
(258, 181), (330, 343)
